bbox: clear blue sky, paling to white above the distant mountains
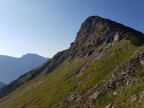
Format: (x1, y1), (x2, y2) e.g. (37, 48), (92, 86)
(0, 0), (144, 57)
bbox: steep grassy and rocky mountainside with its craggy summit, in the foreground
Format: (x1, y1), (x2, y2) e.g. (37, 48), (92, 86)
(0, 16), (144, 108)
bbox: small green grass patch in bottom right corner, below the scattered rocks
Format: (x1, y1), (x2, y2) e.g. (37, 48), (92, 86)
(93, 85), (144, 108)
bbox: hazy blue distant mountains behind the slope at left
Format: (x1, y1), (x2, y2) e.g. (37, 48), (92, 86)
(0, 53), (48, 83)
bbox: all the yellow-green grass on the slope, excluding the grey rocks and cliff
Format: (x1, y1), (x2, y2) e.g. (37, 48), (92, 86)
(0, 40), (144, 108)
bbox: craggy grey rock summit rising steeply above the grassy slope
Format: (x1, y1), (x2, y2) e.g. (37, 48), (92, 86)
(67, 16), (143, 60)
